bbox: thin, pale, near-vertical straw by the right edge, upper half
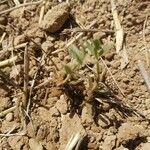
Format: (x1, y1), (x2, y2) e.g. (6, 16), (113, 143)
(143, 14), (150, 67)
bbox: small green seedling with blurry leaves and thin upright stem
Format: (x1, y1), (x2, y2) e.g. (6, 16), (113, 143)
(64, 39), (104, 83)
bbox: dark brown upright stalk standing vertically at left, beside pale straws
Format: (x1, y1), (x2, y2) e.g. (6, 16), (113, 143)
(23, 46), (29, 109)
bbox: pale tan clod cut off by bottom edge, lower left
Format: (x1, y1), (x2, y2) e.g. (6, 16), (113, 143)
(29, 138), (43, 150)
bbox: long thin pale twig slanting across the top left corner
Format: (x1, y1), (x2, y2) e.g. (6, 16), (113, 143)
(0, 0), (43, 15)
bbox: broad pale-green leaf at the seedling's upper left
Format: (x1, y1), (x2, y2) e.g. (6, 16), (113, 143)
(69, 45), (85, 65)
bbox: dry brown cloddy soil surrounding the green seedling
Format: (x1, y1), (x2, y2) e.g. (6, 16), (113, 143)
(0, 0), (150, 150)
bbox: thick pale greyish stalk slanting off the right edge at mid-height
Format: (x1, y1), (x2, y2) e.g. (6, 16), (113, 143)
(138, 60), (150, 93)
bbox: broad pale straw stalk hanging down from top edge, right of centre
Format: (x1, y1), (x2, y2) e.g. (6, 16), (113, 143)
(111, 0), (124, 53)
